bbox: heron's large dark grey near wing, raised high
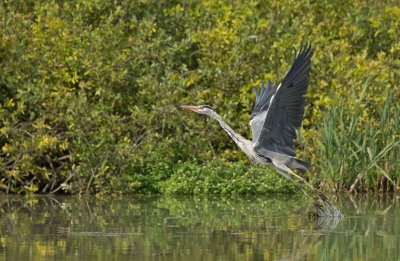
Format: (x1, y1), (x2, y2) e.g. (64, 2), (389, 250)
(252, 44), (313, 156)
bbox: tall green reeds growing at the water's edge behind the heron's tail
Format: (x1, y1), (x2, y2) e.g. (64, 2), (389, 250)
(316, 81), (400, 191)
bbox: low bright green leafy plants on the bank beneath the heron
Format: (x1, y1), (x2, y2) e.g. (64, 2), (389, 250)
(161, 161), (295, 194)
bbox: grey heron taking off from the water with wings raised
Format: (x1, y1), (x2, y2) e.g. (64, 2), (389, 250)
(181, 43), (331, 213)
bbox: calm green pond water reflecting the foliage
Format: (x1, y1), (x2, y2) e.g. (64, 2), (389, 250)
(0, 195), (400, 261)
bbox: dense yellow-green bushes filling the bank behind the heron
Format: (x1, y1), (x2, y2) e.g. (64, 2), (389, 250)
(0, 0), (400, 193)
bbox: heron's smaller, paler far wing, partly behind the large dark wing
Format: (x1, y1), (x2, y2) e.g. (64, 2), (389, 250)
(250, 81), (277, 142)
